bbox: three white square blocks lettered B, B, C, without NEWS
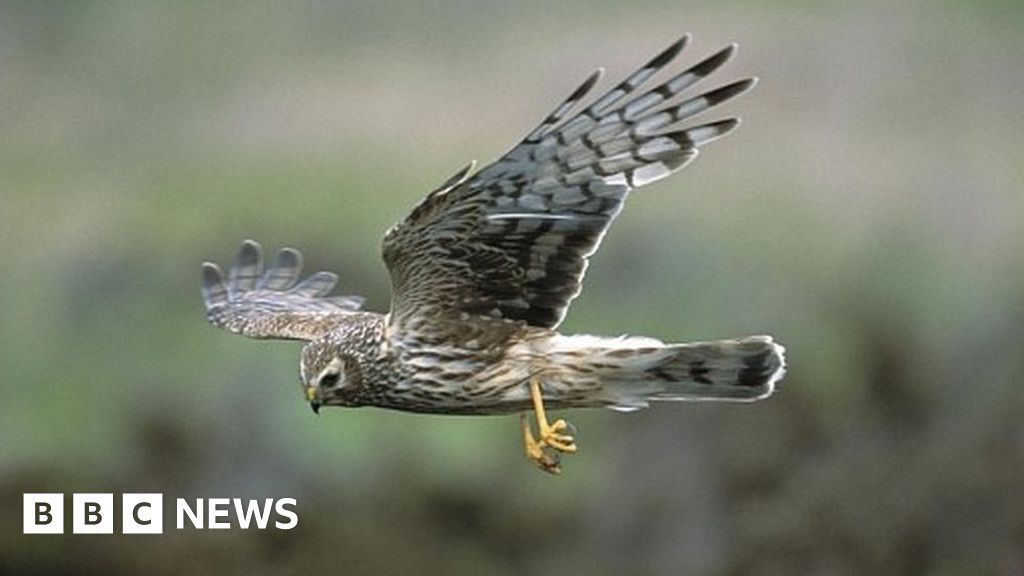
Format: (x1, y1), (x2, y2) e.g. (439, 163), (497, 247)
(22, 494), (164, 534)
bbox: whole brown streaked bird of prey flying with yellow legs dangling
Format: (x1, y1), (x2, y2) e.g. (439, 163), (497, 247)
(203, 35), (784, 474)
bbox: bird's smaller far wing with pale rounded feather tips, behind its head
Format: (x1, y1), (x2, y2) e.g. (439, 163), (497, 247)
(203, 240), (362, 340)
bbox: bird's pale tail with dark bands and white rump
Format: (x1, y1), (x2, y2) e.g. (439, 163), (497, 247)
(549, 336), (785, 410)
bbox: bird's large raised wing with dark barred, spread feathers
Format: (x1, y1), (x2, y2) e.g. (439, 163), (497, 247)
(383, 35), (755, 328)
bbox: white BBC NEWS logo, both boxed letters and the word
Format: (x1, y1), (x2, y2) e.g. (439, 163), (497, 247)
(22, 493), (299, 534)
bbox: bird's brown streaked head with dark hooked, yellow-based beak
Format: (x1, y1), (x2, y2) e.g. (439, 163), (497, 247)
(299, 342), (360, 413)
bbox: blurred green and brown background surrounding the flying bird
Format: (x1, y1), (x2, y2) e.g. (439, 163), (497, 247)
(0, 0), (1024, 576)
